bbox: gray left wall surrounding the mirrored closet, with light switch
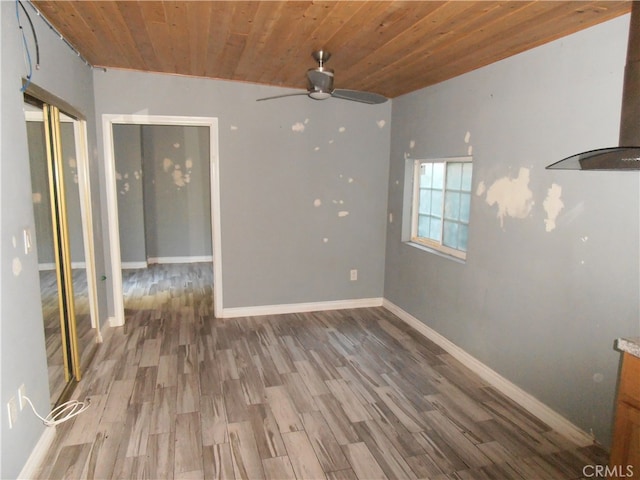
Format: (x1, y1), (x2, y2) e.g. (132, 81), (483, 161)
(0, 2), (107, 478)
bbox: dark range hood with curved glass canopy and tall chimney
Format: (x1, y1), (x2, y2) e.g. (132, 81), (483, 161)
(547, 1), (640, 170)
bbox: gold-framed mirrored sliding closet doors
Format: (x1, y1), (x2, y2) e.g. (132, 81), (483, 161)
(25, 96), (97, 406)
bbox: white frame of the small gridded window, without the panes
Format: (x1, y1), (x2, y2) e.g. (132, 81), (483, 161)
(410, 157), (473, 260)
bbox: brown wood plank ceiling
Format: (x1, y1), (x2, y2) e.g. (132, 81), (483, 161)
(33, 0), (631, 98)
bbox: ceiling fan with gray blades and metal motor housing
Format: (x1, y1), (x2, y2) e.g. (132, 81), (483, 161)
(257, 50), (387, 105)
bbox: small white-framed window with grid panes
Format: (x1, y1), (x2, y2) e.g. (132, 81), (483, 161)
(411, 157), (473, 259)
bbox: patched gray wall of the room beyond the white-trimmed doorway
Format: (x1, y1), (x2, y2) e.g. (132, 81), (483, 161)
(113, 124), (212, 267)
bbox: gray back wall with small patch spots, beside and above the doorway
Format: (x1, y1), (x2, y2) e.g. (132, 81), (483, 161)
(94, 69), (391, 308)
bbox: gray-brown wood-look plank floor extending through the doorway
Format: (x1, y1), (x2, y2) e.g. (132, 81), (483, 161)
(39, 264), (607, 480)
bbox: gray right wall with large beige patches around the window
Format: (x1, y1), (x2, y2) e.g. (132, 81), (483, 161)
(385, 16), (640, 450)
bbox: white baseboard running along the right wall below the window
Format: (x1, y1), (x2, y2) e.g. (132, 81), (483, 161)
(382, 299), (594, 447)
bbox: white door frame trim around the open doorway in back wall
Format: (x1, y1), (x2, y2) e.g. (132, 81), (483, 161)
(102, 114), (223, 327)
